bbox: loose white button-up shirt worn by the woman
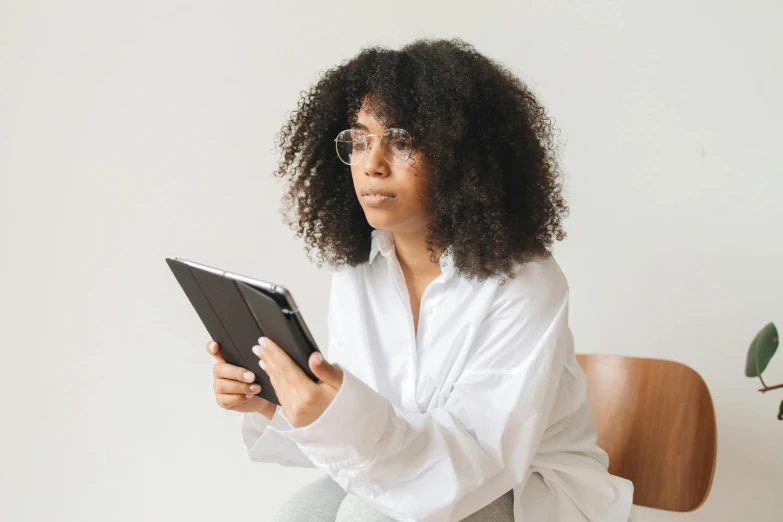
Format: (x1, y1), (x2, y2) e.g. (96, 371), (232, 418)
(242, 230), (633, 522)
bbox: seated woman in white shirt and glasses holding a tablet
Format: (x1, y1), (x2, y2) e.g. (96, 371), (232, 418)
(208, 40), (632, 522)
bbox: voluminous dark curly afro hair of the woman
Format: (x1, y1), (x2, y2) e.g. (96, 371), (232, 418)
(275, 39), (568, 280)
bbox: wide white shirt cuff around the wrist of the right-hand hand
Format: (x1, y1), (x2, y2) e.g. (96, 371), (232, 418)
(269, 370), (396, 471)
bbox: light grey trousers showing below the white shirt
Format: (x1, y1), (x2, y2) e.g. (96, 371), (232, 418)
(273, 476), (514, 522)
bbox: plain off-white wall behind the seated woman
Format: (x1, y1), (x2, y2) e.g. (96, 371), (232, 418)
(0, 0), (783, 522)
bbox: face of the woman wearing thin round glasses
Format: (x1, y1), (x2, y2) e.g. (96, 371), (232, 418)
(351, 108), (427, 234)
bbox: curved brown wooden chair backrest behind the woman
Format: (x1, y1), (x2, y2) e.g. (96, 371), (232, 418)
(577, 354), (717, 511)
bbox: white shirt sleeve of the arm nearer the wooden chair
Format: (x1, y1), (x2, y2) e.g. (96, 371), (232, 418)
(276, 266), (572, 521)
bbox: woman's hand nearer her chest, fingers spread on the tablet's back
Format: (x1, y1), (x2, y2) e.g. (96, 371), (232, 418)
(253, 337), (343, 428)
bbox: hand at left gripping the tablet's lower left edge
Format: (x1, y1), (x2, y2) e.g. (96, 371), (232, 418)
(207, 340), (276, 420)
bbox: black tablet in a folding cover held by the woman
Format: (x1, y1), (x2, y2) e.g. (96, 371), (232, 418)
(166, 258), (318, 405)
